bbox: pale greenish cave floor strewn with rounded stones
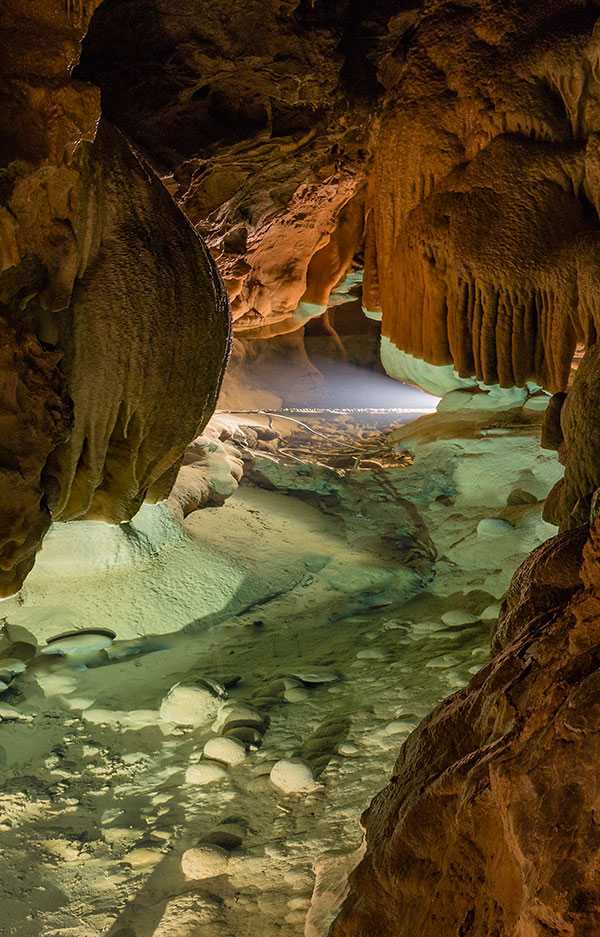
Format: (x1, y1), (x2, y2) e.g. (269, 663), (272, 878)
(0, 412), (560, 937)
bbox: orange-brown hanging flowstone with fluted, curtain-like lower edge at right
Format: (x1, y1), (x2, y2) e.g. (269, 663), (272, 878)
(364, 0), (600, 390)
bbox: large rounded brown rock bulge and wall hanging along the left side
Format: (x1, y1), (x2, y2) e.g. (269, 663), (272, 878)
(0, 0), (229, 596)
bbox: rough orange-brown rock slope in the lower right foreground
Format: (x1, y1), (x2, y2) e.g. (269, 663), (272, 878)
(331, 523), (600, 937)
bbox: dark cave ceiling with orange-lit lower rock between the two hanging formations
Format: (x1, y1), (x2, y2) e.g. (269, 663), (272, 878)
(78, 0), (372, 337)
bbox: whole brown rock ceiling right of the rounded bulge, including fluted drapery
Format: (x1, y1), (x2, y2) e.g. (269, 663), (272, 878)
(78, 0), (600, 391)
